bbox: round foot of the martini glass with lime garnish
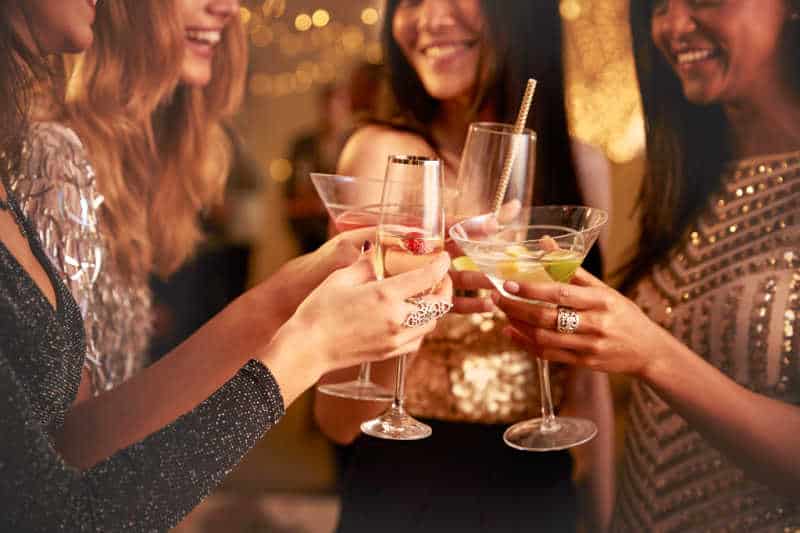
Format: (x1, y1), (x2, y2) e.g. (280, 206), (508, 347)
(503, 416), (597, 452)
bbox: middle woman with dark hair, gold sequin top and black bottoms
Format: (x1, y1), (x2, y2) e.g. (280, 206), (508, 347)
(315, 0), (612, 531)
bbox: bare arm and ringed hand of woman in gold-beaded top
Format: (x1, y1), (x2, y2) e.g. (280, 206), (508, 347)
(500, 271), (800, 497)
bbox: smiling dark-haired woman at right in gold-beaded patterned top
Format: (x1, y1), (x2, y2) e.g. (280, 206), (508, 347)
(501, 0), (800, 531)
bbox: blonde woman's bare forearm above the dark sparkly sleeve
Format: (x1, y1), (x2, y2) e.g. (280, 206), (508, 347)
(56, 288), (280, 468)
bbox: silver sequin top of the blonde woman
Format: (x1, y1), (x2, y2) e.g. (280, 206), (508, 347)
(9, 122), (152, 394)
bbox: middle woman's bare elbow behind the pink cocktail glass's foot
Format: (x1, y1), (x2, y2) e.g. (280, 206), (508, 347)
(314, 359), (397, 445)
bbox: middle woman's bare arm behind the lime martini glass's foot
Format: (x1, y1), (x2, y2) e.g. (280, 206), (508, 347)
(567, 368), (615, 532)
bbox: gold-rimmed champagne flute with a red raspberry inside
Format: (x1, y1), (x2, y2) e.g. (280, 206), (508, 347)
(361, 155), (445, 440)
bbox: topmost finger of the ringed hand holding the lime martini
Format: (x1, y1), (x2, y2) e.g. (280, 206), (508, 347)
(498, 281), (610, 311)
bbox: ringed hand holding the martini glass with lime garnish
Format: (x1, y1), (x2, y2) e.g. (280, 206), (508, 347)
(497, 269), (677, 377)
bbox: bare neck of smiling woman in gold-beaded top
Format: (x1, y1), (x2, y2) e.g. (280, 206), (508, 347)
(723, 84), (800, 159)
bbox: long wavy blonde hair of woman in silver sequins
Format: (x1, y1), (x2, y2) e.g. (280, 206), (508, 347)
(66, 0), (247, 276)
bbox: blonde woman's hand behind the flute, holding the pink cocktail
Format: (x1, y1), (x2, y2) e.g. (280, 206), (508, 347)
(265, 228), (375, 322)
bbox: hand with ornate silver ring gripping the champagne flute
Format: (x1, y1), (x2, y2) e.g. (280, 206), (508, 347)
(279, 248), (452, 377)
